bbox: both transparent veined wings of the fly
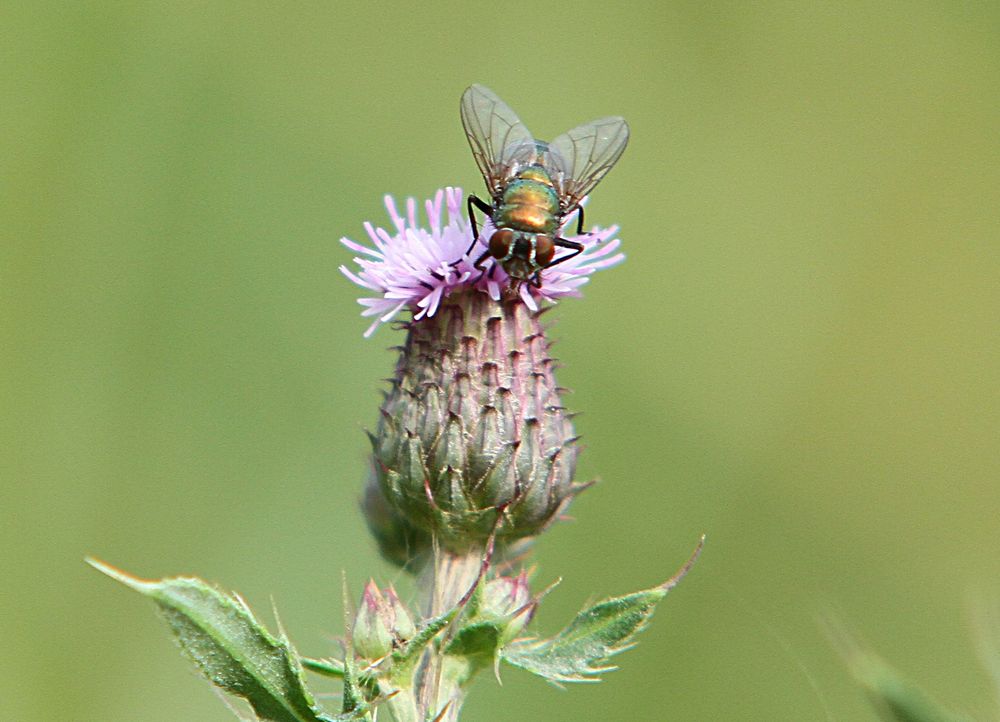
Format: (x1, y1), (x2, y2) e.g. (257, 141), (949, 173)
(461, 85), (628, 215)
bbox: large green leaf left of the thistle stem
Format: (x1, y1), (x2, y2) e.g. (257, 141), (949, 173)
(87, 559), (331, 722)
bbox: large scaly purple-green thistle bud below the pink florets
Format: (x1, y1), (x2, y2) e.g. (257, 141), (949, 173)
(373, 290), (583, 552)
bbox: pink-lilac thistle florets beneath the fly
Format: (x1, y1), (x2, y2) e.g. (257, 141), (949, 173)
(340, 188), (625, 337)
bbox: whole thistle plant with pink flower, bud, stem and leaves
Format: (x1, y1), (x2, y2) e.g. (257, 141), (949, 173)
(92, 188), (701, 722)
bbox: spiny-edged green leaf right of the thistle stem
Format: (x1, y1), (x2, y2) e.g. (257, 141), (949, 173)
(500, 537), (705, 683)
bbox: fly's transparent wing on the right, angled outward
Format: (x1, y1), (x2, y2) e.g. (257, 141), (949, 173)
(545, 116), (628, 213)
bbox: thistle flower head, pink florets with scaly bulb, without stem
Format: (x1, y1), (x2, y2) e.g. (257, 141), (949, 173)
(341, 188), (624, 565)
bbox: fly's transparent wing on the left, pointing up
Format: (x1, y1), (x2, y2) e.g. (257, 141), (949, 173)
(461, 85), (537, 195)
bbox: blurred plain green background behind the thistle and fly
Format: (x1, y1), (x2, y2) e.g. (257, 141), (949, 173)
(0, 1), (1000, 722)
